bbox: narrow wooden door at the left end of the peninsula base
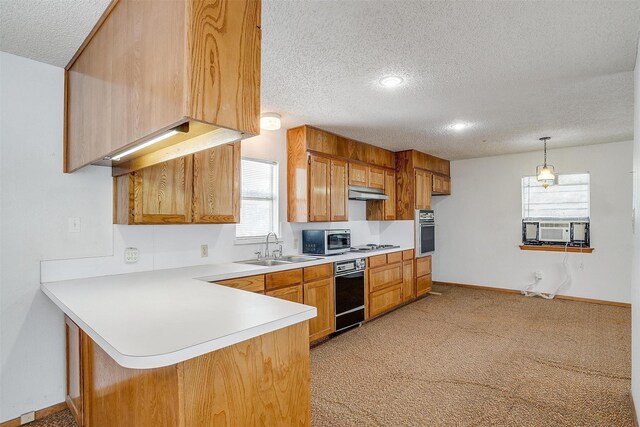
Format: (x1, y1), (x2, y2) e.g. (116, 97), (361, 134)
(64, 316), (83, 426)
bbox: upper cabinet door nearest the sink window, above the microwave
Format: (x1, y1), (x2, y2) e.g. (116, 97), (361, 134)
(309, 156), (331, 222)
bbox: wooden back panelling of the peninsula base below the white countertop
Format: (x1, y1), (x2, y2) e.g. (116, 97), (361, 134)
(68, 322), (311, 427)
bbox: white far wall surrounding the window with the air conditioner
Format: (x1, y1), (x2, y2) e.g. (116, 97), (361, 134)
(433, 140), (632, 302)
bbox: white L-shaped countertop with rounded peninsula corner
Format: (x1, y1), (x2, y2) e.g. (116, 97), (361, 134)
(41, 247), (412, 369)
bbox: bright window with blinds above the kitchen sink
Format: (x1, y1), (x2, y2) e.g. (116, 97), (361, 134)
(236, 158), (278, 241)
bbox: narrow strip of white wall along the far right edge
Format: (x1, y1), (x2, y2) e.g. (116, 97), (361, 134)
(631, 41), (640, 422)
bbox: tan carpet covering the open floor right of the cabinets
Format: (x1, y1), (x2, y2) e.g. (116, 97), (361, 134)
(311, 286), (632, 426)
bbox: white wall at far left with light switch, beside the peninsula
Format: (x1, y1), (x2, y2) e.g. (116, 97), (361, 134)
(0, 53), (112, 421)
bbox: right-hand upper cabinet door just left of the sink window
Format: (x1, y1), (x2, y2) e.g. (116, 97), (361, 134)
(193, 142), (240, 224)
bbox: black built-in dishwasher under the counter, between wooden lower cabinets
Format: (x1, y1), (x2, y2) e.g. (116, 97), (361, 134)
(334, 258), (366, 332)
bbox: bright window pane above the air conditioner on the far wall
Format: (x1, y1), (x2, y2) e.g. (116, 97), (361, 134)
(522, 173), (591, 220)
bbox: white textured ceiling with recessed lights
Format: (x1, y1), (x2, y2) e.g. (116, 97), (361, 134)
(0, 0), (640, 159)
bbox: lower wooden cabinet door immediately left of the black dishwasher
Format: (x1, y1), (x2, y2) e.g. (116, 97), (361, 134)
(304, 278), (335, 341)
